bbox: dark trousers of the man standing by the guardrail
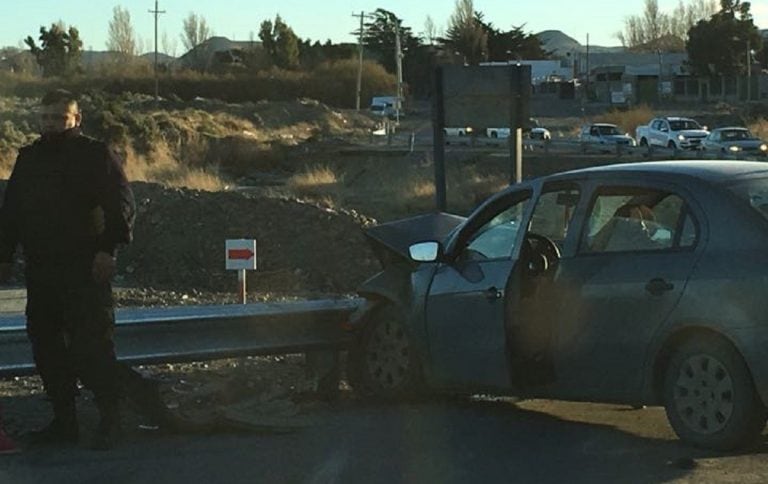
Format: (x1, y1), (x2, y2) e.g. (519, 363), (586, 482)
(26, 274), (120, 408)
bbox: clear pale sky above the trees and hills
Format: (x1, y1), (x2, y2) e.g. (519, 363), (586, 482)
(0, 0), (768, 55)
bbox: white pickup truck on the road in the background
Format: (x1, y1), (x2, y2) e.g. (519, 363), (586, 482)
(635, 117), (709, 150)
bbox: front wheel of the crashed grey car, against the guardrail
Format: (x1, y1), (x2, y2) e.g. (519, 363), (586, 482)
(347, 304), (424, 400)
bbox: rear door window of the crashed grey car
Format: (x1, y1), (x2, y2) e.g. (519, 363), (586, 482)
(580, 188), (697, 253)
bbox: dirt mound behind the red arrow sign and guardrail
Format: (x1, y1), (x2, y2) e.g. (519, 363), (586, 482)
(117, 182), (379, 294)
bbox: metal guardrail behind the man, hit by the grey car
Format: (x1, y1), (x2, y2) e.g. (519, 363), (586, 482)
(0, 299), (362, 376)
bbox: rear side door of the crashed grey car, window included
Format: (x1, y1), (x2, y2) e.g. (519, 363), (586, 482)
(548, 184), (700, 401)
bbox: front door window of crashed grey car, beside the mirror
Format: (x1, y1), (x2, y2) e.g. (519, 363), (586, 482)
(461, 198), (528, 260)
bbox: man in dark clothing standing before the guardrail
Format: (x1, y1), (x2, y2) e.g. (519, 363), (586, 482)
(0, 90), (159, 449)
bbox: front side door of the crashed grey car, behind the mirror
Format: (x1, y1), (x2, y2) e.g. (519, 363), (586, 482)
(425, 187), (531, 389)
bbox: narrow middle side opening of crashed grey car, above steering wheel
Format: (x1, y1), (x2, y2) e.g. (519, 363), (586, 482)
(528, 186), (579, 250)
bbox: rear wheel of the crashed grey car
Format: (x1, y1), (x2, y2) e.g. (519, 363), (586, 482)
(664, 336), (766, 450)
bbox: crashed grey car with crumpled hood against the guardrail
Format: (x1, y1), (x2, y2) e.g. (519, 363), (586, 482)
(348, 160), (768, 449)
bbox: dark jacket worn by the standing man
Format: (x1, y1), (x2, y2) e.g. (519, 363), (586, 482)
(0, 128), (135, 264)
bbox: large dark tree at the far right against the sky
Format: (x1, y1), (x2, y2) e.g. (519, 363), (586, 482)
(686, 0), (762, 75)
